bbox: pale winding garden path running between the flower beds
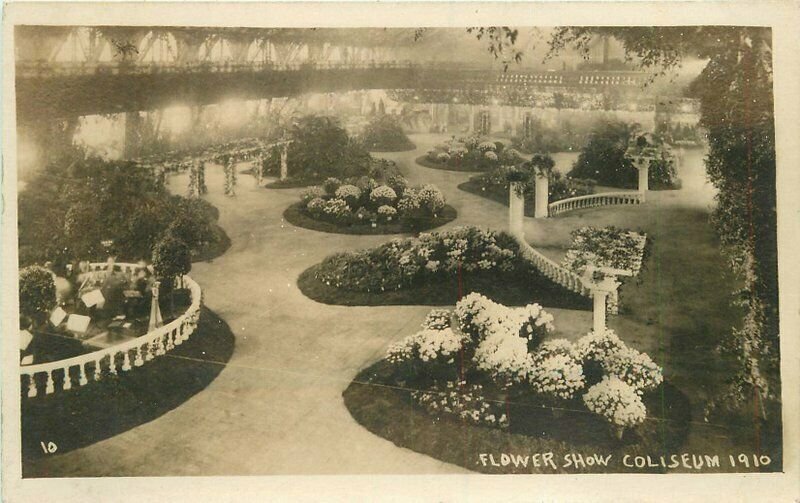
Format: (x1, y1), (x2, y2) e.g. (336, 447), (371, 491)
(31, 135), (736, 476)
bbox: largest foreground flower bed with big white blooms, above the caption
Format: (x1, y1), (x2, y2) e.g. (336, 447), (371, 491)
(344, 293), (689, 473)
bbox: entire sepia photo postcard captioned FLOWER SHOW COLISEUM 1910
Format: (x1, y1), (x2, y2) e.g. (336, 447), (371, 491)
(3, 2), (797, 501)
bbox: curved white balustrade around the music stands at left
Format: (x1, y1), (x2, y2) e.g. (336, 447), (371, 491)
(19, 263), (202, 398)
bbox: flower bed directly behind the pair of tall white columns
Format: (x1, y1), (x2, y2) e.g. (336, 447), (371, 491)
(458, 165), (595, 217)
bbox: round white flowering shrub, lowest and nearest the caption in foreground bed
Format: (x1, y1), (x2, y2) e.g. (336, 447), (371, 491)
(583, 376), (647, 437)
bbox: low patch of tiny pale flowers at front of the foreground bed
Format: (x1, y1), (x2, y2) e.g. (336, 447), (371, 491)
(411, 381), (508, 428)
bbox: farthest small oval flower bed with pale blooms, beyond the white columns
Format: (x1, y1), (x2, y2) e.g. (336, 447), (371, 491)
(417, 136), (524, 171)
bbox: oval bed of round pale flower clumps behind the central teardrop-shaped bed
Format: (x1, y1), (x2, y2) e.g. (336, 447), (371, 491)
(284, 174), (457, 234)
